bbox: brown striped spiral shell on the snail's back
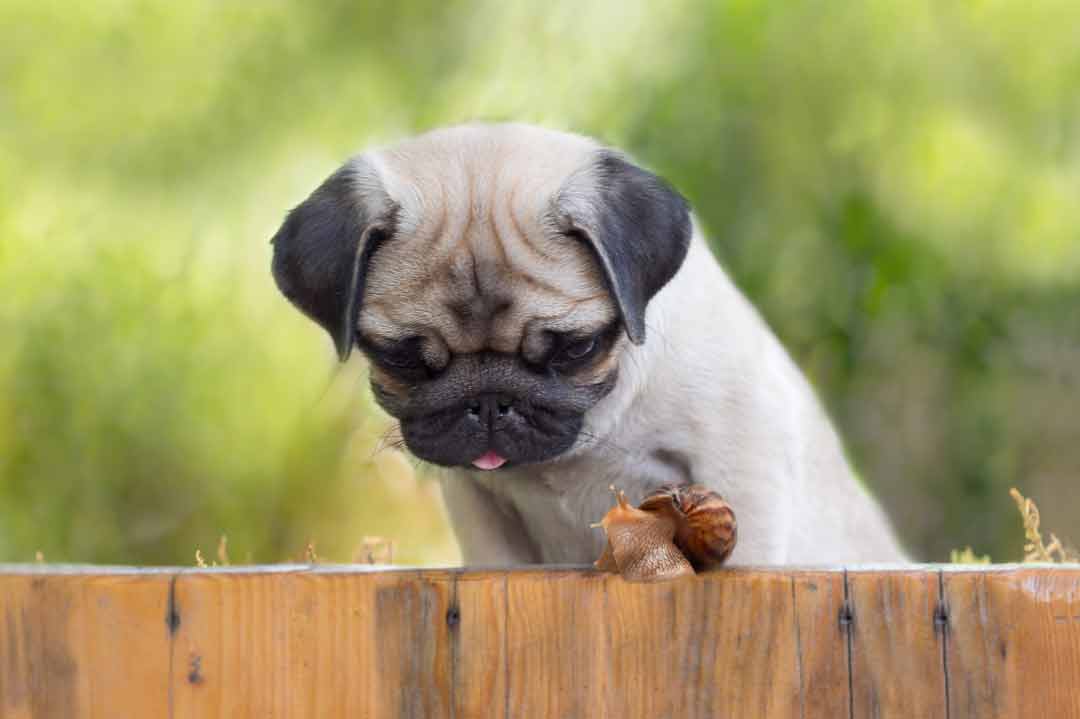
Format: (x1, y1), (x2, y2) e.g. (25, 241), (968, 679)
(640, 485), (739, 571)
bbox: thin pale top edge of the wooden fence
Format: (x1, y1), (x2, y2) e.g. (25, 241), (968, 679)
(0, 562), (1080, 576)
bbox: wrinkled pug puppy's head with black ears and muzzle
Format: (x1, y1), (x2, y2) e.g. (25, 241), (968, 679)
(272, 125), (691, 469)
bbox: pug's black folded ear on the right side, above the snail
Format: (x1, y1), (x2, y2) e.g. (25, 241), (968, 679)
(555, 150), (692, 344)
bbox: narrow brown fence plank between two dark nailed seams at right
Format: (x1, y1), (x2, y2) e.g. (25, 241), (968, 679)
(848, 570), (947, 719)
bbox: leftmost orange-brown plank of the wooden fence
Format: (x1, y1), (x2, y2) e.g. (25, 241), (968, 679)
(0, 573), (171, 719)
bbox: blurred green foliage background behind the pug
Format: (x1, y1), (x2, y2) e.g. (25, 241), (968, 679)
(0, 0), (1080, 564)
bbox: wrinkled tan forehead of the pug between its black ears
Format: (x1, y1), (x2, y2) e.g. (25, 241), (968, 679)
(362, 125), (617, 354)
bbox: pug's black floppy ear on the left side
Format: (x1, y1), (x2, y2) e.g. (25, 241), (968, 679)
(270, 159), (395, 362)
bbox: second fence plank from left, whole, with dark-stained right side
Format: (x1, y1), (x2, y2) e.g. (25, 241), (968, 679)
(173, 571), (460, 718)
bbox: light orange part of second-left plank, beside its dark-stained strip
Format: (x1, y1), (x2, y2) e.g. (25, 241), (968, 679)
(171, 561), (384, 717)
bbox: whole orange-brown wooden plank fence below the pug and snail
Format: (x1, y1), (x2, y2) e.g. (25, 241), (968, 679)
(0, 566), (1080, 719)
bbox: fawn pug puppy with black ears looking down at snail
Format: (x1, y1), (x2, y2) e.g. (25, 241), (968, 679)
(272, 124), (904, 565)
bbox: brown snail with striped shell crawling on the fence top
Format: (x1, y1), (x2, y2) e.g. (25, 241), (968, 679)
(593, 485), (738, 582)
